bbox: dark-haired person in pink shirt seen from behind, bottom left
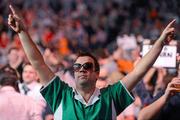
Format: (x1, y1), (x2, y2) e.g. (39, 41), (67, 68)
(0, 66), (42, 120)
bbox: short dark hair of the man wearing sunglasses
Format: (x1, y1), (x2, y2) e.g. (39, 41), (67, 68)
(77, 51), (100, 72)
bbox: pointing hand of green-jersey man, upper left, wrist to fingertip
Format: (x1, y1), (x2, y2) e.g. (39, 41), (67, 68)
(8, 5), (25, 33)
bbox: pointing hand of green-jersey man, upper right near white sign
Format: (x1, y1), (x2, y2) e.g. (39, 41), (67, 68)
(159, 19), (176, 44)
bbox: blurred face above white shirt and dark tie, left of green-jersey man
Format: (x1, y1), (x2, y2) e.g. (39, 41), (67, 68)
(22, 65), (38, 84)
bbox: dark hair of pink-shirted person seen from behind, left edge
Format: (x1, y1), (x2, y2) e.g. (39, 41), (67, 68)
(0, 65), (18, 89)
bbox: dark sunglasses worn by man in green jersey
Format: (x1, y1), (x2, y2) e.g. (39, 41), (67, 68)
(73, 62), (93, 72)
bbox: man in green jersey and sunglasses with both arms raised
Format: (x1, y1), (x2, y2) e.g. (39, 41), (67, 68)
(8, 5), (175, 120)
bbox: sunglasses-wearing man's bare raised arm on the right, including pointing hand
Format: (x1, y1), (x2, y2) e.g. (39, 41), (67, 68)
(122, 20), (175, 91)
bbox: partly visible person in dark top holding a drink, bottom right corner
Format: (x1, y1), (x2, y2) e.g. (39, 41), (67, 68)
(138, 77), (180, 120)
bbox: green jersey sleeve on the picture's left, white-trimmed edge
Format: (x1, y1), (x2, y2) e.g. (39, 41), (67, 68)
(40, 76), (69, 113)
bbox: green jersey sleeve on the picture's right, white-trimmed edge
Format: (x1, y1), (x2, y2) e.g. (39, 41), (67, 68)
(110, 81), (134, 115)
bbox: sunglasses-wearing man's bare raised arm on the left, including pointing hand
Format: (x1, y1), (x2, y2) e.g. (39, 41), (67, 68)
(8, 5), (55, 85)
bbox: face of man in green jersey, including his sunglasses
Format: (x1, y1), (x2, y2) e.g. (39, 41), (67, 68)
(73, 56), (98, 86)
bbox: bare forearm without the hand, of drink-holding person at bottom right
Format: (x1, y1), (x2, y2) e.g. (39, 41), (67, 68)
(138, 96), (166, 120)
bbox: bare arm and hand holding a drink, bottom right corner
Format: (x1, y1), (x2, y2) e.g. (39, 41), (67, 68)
(138, 78), (180, 120)
